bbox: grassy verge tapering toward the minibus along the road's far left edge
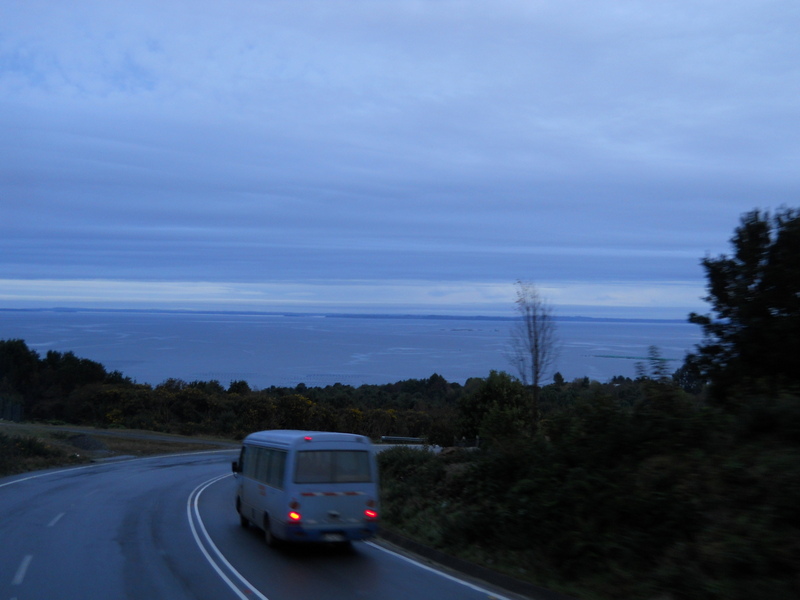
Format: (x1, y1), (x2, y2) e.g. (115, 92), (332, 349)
(0, 422), (237, 477)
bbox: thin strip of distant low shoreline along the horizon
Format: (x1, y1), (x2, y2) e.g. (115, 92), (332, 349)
(0, 306), (687, 324)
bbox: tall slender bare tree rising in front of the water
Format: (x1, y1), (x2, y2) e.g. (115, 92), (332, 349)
(508, 280), (556, 432)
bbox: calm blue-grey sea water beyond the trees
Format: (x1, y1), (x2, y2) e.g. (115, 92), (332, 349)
(0, 310), (701, 388)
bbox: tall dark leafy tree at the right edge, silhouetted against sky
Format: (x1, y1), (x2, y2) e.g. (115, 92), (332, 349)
(687, 208), (800, 408)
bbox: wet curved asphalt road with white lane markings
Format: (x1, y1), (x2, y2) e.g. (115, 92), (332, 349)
(0, 451), (520, 600)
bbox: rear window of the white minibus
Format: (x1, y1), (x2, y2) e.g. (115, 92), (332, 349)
(294, 450), (372, 483)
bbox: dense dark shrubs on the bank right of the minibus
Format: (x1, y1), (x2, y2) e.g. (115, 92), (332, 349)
(381, 381), (800, 600)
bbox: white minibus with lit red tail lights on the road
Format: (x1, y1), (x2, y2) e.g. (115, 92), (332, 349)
(232, 430), (379, 546)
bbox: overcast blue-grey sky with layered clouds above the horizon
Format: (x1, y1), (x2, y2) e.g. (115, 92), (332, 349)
(0, 0), (800, 318)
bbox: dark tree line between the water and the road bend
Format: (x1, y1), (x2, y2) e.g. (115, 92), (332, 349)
(0, 340), (712, 446)
